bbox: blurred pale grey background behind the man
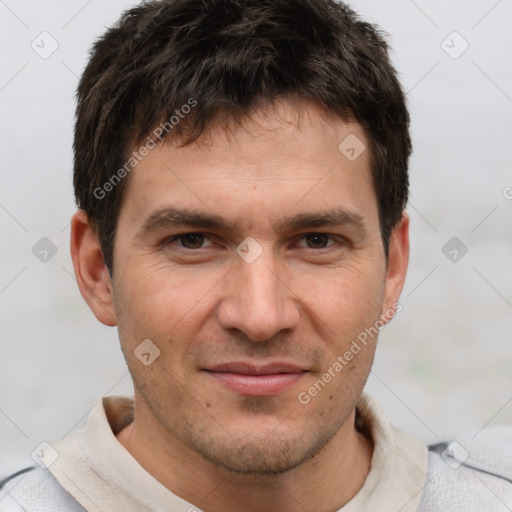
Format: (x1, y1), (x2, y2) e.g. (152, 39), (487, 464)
(0, 0), (512, 476)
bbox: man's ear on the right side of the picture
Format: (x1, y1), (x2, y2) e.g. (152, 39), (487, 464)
(381, 212), (409, 323)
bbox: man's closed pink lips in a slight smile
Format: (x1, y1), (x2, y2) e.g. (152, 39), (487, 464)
(204, 361), (308, 396)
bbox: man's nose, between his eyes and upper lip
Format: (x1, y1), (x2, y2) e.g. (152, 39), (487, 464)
(217, 245), (300, 341)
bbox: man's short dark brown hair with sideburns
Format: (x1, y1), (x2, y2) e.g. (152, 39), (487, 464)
(74, 0), (411, 273)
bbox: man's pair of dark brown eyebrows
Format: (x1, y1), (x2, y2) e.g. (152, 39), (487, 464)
(139, 207), (367, 234)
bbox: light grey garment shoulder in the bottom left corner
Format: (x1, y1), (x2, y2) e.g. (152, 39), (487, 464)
(0, 466), (85, 512)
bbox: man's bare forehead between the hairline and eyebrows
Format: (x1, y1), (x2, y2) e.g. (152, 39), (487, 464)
(121, 102), (377, 232)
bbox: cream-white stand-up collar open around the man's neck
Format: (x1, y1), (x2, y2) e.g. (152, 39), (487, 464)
(45, 393), (428, 512)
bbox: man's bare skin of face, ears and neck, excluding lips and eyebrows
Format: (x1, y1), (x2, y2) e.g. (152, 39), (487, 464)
(71, 102), (409, 512)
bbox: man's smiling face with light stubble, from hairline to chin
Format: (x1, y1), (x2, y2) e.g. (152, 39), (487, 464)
(112, 103), (404, 473)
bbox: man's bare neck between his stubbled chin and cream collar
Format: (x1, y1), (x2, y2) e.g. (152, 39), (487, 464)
(117, 402), (373, 512)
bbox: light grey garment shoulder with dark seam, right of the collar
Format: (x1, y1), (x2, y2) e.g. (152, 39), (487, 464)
(418, 427), (512, 512)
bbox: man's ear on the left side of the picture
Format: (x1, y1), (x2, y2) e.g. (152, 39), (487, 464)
(71, 210), (117, 326)
